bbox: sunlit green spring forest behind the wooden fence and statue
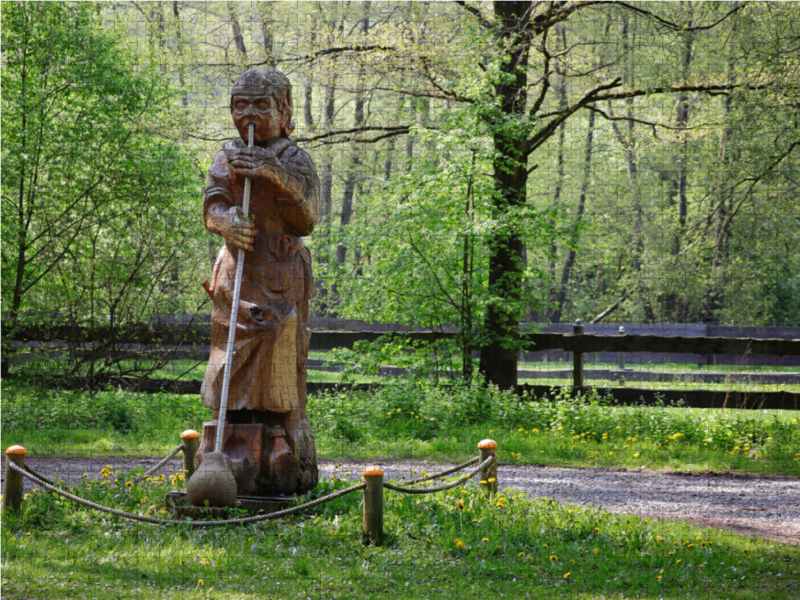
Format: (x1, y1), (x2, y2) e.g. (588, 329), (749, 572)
(2, 2), (800, 387)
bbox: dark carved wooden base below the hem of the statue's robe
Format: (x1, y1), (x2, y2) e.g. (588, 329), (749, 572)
(195, 410), (319, 496)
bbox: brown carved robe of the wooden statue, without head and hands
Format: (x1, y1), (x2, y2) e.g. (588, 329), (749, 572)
(200, 137), (320, 413)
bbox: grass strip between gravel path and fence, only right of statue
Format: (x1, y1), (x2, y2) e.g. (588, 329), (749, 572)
(309, 378), (800, 473)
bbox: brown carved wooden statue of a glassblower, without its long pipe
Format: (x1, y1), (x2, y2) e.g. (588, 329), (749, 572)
(197, 68), (320, 496)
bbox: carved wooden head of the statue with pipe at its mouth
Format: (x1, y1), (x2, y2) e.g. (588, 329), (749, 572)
(231, 67), (294, 143)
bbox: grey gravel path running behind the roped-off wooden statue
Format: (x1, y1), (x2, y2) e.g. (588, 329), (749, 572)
(4, 455), (800, 545)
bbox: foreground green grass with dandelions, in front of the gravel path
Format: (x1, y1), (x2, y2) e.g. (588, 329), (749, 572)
(2, 471), (800, 600)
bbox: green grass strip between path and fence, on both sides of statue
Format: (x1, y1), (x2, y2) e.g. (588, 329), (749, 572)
(2, 380), (800, 475)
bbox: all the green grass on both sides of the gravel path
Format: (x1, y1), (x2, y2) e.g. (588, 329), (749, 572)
(2, 379), (800, 600)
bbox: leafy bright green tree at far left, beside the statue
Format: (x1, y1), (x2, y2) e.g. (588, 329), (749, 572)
(2, 3), (201, 375)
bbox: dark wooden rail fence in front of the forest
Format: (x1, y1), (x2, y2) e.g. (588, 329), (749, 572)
(10, 320), (800, 410)
